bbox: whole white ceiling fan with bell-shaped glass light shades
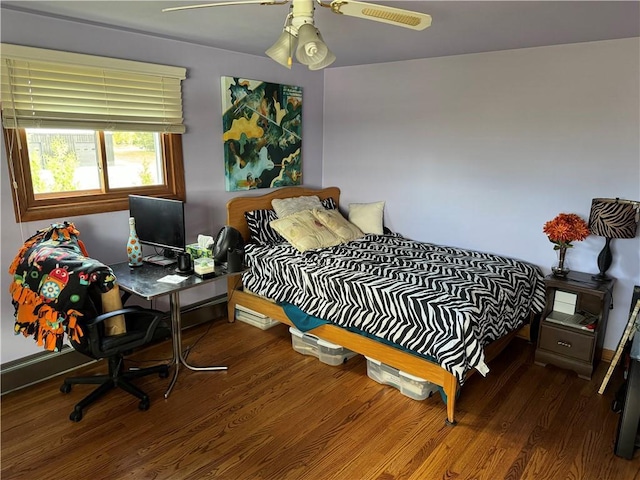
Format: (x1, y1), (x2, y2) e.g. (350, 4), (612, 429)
(162, 0), (431, 70)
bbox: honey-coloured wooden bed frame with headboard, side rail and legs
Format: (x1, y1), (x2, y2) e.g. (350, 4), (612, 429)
(227, 187), (516, 425)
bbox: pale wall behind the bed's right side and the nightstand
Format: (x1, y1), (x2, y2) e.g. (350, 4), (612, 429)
(323, 38), (640, 350)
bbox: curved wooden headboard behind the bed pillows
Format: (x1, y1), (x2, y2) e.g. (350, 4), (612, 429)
(227, 187), (340, 242)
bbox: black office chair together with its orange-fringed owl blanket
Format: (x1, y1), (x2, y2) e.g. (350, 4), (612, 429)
(9, 222), (171, 422)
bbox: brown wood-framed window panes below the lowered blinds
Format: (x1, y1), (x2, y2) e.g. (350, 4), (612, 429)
(5, 129), (185, 222)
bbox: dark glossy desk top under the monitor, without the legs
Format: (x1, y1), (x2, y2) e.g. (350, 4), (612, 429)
(109, 262), (242, 300)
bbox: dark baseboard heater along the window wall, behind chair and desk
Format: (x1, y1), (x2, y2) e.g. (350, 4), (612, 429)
(0, 295), (227, 395)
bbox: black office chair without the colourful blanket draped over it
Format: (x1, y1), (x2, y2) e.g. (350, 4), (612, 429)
(60, 293), (170, 422)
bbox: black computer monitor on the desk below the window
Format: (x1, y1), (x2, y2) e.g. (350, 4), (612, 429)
(129, 195), (185, 258)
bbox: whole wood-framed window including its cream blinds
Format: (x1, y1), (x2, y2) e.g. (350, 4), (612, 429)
(1, 44), (185, 222)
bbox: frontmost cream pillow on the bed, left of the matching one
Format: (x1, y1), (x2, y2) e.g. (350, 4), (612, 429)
(271, 210), (342, 252)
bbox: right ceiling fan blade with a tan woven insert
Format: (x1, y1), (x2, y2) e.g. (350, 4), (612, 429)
(330, 0), (431, 30)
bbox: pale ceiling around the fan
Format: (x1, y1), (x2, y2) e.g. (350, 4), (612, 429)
(0, 0), (640, 67)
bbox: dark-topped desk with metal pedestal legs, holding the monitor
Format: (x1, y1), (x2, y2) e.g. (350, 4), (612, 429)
(110, 262), (241, 398)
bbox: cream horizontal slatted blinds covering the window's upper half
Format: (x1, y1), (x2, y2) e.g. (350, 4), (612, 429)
(0, 43), (186, 133)
